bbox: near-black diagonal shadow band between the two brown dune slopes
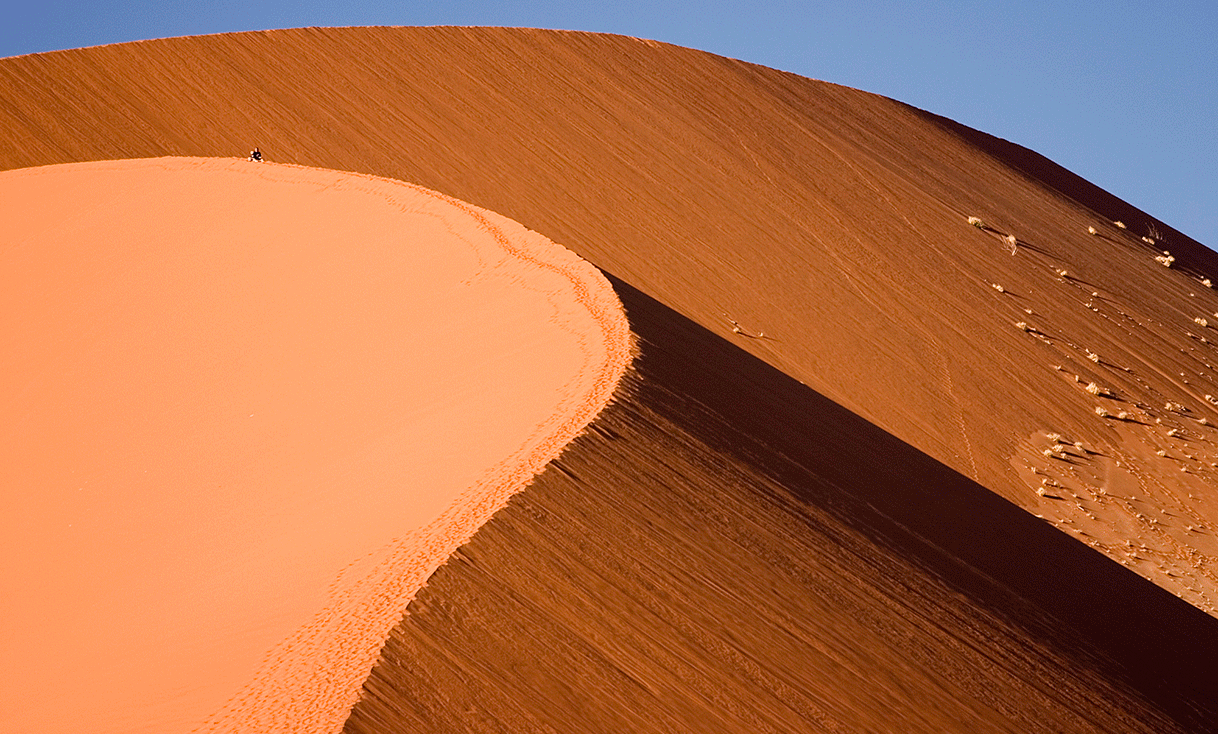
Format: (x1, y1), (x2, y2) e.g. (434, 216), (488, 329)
(610, 276), (1218, 732)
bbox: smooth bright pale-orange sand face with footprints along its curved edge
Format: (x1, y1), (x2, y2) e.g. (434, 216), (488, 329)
(0, 158), (631, 733)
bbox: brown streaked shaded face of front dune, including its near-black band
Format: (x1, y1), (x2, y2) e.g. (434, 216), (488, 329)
(346, 277), (1218, 734)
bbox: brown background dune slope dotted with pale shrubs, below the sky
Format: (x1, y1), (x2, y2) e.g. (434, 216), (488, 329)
(0, 28), (1218, 610)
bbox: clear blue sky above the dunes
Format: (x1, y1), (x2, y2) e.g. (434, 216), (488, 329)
(0, 0), (1218, 248)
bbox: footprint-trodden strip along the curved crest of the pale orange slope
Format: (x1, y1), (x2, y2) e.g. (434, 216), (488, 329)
(196, 167), (633, 733)
